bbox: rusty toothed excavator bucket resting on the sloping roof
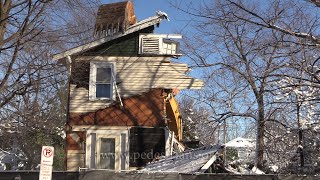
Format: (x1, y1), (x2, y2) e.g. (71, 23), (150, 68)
(94, 1), (137, 37)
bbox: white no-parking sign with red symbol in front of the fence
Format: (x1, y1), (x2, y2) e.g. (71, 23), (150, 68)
(39, 146), (54, 180)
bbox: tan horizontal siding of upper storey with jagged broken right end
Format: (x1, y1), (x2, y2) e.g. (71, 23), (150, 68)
(70, 56), (203, 113)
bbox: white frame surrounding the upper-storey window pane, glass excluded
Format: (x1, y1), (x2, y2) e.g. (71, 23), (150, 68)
(89, 61), (116, 100)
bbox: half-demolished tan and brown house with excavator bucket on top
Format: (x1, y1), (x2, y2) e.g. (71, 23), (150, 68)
(53, 1), (203, 170)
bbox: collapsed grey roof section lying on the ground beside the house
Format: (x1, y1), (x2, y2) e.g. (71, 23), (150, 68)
(142, 146), (222, 173)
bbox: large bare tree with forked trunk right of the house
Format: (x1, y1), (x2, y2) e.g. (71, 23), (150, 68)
(169, 1), (313, 168)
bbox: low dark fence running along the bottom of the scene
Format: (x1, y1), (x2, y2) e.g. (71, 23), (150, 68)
(0, 170), (320, 180)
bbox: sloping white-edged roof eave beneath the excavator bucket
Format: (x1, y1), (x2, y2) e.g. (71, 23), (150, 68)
(53, 14), (167, 60)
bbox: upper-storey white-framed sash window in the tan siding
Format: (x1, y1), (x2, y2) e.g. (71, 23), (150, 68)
(89, 62), (115, 100)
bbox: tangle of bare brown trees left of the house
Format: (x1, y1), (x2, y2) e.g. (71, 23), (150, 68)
(0, 0), (98, 170)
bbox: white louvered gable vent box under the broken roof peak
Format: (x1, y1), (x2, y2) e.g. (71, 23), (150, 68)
(139, 34), (182, 55)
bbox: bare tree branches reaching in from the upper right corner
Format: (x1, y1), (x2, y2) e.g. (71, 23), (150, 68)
(214, 0), (320, 83)
